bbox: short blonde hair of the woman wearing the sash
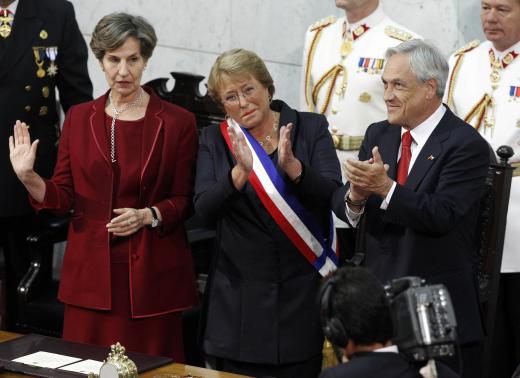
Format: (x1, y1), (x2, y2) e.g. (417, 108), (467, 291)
(208, 49), (274, 103)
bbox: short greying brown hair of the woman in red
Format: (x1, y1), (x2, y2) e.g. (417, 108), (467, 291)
(90, 13), (157, 61)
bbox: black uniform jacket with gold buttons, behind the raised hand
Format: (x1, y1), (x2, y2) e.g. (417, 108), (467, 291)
(0, 0), (92, 217)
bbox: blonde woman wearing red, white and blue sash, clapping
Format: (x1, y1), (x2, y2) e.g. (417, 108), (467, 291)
(195, 49), (341, 378)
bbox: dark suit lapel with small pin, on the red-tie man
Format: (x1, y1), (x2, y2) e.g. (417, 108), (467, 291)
(405, 108), (452, 190)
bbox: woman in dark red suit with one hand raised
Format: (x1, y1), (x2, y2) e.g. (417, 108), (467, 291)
(9, 13), (197, 362)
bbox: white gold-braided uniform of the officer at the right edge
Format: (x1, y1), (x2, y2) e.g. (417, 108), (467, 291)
(445, 41), (520, 272)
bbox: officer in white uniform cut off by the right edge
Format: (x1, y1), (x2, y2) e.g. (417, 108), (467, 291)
(445, 0), (520, 377)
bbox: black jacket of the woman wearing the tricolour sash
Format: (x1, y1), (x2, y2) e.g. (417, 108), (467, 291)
(195, 101), (341, 364)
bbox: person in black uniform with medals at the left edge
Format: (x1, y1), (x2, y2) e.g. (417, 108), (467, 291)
(0, 0), (92, 326)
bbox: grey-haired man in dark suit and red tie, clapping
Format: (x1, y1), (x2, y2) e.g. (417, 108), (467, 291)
(333, 40), (489, 377)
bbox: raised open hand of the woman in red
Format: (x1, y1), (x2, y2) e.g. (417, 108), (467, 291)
(9, 121), (39, 182)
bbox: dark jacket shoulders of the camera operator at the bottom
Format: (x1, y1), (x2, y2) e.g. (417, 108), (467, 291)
(320, 352), (459, 378)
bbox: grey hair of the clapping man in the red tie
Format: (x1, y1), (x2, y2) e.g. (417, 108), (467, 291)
(386, 39), (449, 98)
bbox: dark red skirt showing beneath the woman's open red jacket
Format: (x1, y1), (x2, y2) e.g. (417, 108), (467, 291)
(63, 242), (185, 363)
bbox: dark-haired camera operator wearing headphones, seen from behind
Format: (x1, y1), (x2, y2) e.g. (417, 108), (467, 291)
(320, 266), (459, 378)
